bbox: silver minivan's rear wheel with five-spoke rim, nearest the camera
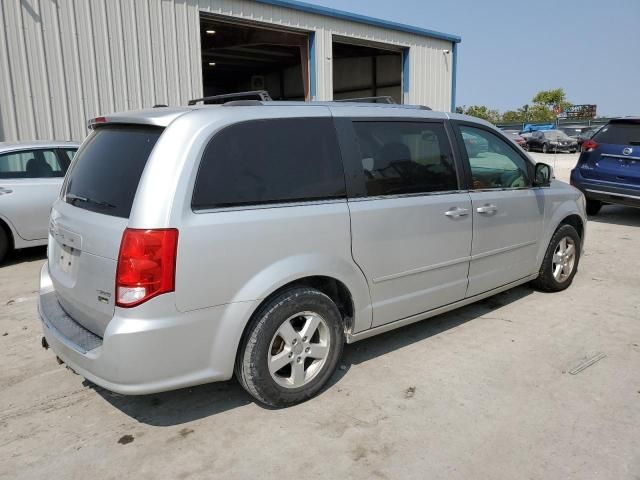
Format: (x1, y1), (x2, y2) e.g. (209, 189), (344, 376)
(235, 287), (344, 407)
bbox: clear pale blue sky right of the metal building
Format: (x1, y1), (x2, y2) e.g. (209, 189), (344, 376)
(305, 0), (640, 116)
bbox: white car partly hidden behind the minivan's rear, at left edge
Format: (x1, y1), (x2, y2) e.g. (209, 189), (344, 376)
(0, 141), (79, 261)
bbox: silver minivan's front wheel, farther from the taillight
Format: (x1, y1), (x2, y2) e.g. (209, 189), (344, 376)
(533, 224), (581, 292)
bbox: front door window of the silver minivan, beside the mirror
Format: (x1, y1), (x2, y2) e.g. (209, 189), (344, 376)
(460, 125), (531, 190)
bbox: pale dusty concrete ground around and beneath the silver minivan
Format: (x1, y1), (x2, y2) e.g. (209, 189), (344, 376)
(0, 154), (640, 480)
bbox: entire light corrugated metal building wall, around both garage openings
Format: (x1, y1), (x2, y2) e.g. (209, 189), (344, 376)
(0, 0), (452, 141)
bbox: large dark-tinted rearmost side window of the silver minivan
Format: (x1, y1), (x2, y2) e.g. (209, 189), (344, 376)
(192, 118), (345, 208)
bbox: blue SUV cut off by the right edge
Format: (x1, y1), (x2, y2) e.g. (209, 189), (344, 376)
(571, 117), (640, 215)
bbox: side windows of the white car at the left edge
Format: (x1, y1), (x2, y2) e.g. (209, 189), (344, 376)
(0, 150), (65, 178)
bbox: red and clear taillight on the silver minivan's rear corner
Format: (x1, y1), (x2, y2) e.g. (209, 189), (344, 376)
(116, 228), (178, 308)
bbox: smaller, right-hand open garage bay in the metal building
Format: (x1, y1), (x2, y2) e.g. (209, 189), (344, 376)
(333, 41), (402, 103)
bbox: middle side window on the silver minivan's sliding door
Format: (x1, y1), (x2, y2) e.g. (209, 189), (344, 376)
(353, 121), (458, 196)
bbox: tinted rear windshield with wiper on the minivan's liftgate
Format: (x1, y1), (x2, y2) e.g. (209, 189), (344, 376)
(65, 125), (162, 218)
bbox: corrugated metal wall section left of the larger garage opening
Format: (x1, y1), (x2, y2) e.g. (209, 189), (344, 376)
(0, 0), (202, 141)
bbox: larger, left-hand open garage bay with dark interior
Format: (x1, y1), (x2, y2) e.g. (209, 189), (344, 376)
(200, 15), (309, 100)
